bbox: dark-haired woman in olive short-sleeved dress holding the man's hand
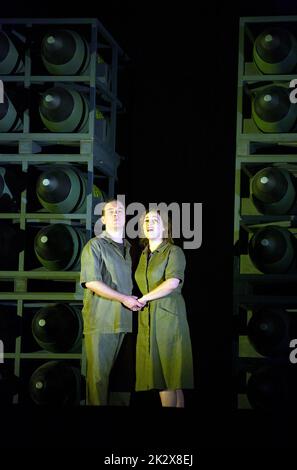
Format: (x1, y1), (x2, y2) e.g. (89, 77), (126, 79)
(135, 211), (193, 407)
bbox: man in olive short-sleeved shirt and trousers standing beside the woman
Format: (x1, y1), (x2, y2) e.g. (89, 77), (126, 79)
(80, 199), (143, 405)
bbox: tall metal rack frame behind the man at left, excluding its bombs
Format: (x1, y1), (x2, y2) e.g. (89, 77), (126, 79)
(0, 19), (123, 404)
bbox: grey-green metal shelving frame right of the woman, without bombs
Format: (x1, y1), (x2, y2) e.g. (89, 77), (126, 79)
(232, 16), (297, 412)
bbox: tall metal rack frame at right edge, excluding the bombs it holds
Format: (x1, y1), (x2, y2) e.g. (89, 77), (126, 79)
(233, 16), (297, 409)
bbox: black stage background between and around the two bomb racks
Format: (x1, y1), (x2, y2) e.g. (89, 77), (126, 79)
(1, 0), (297, 450)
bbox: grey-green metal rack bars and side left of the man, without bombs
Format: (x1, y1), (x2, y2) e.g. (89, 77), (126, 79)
(0, 18), (124, 404)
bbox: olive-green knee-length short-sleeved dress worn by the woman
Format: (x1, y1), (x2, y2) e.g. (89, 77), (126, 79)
(135, 240), (193, 391)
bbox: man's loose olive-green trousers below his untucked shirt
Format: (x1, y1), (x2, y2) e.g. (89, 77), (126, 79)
(85, 333), (130, 405)
